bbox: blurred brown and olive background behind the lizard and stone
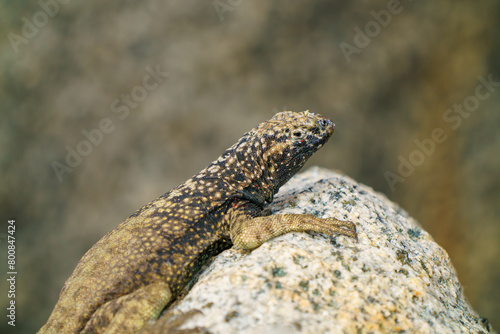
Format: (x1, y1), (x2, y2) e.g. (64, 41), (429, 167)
(0, 0), (500, 333)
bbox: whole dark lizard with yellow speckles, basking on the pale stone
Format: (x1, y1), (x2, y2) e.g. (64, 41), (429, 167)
(38, 111), (357, 334)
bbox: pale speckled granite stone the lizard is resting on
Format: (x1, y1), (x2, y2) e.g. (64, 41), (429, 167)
(167, 167), (488, 334)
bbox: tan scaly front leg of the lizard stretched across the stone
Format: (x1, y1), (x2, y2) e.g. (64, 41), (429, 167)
(230, 214), (357, 249)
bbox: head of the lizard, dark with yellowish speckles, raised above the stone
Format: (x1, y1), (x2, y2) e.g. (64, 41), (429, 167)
(254, 111), (335, 192)
